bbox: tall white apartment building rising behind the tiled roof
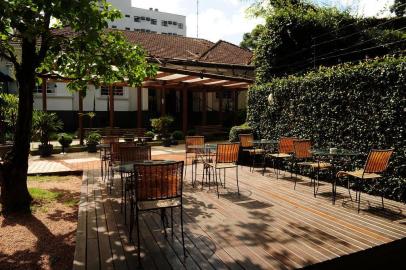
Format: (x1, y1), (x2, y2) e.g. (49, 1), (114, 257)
(108, 0), (186, 36)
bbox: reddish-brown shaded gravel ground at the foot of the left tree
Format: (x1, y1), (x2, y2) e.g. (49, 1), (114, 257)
(0, 176), (81, 270)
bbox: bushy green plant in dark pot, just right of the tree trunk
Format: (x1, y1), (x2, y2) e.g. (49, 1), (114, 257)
(32, 111), (63, 157)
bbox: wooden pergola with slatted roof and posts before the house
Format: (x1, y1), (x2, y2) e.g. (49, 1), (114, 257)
(38, 58), (254, 143)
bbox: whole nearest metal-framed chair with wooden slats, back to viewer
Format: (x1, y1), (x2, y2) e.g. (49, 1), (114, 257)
(130, 161), (186, 263)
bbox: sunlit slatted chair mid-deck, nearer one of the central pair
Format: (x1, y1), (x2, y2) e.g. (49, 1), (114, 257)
(202, 143), (240, 198)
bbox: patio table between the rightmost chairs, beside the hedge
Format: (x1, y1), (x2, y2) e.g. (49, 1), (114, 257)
(310, 149), (362, 204)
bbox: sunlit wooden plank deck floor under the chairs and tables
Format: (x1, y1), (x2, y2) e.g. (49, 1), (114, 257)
(74, 164), (406, 270)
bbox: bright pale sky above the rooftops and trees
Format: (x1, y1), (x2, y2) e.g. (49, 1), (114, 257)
(132, 0), (394, 45)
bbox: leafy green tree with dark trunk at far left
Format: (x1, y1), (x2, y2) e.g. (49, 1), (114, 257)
(0, 0), (155, 212)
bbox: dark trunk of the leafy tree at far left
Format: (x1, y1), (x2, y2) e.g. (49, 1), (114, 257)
(0, 39), (36, 213)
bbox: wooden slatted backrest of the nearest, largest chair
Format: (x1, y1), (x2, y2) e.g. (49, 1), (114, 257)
(134, 161), (184, 201)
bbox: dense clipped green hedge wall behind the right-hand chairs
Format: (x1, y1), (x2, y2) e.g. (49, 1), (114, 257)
(247, 57), (406, 202)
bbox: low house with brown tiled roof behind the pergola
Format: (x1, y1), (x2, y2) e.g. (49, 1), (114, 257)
(0, 29), (254, 132)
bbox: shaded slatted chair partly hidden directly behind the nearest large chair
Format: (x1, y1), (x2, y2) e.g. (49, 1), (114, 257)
(118, 145), (151, 222)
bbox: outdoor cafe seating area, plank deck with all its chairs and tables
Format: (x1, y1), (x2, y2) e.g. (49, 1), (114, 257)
(74, 134), (406, 269)
